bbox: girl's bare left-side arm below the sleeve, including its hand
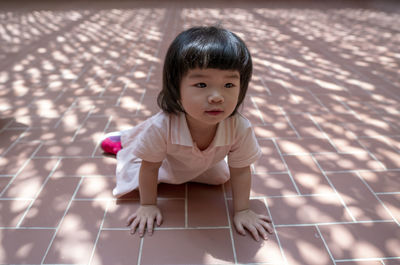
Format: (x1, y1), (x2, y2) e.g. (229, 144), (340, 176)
(127, 160), (162, 237)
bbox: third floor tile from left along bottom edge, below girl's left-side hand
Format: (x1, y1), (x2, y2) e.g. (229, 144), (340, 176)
(90, 230), (140, 265)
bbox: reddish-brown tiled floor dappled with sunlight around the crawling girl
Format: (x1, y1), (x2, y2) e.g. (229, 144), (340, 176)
(0, 0), (400, 265)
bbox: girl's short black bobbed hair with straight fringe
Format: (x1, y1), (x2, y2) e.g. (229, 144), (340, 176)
(157, 27), (253, 115)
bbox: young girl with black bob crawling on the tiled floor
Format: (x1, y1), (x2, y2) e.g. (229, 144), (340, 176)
(102, 27), (272, 241)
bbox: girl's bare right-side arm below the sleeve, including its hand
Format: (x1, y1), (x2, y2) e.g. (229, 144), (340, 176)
(229, 166), (273, 241)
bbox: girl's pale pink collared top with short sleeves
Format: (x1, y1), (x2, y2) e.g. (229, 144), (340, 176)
(113, 112), (261, 197)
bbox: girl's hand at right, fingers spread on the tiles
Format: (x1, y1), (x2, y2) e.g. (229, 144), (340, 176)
(233, 209), (273, 241)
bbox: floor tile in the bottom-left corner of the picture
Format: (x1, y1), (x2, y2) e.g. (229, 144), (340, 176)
(0, 229), (54, 264)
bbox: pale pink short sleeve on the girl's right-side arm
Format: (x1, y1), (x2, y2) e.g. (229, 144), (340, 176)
(228, 116), (261, 168)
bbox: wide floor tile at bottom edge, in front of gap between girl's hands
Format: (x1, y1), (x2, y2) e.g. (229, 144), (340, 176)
(140, 229), (234, 264)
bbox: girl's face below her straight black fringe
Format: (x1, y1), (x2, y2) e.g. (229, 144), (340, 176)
(180, 68), (240, 128)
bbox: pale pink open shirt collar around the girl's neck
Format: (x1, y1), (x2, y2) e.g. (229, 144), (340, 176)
(170, 113), (235, 147)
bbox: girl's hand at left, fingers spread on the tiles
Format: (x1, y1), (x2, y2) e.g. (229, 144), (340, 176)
(127, 205), (162, 237)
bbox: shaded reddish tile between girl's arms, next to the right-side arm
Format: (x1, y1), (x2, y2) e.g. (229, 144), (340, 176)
(187, 183), (228, 227)
